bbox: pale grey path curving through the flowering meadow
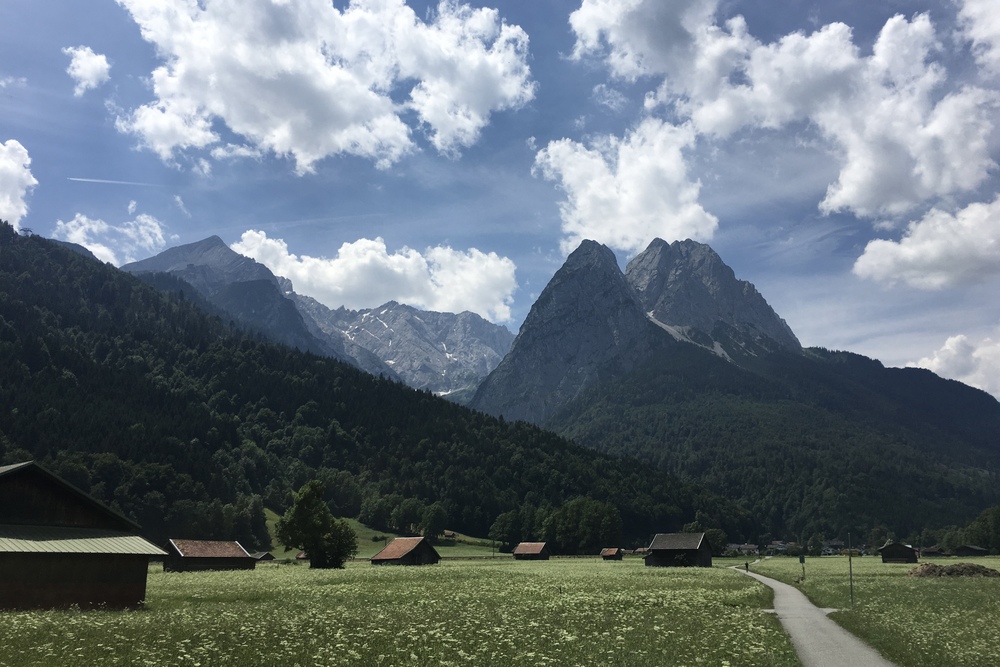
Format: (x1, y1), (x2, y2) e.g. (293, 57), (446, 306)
(737, 568), (896, 667)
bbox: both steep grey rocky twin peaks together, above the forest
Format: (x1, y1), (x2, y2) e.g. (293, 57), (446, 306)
(470, 239), (801, 424)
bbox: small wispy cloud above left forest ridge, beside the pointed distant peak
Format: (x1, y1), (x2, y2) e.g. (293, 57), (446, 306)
(52, 211), (166, 266)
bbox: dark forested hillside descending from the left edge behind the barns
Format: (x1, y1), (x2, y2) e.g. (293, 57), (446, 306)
(0, 223), (755, 550)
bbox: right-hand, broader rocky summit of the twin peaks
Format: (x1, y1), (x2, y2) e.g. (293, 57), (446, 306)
(625, 239), (802, 351)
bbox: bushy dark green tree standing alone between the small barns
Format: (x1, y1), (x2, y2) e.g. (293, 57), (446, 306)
(275, 480), (358, 568)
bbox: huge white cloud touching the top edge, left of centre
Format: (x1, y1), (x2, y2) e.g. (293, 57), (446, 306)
(117, 0), (534, 173)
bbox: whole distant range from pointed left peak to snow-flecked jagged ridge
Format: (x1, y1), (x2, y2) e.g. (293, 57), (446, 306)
(122, 236), (514, 397)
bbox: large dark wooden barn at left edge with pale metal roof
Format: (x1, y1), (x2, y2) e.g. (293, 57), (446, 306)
(0, 461), (166, 609)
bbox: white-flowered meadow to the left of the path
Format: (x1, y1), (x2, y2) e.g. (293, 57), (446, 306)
(0, 559), (799, 667)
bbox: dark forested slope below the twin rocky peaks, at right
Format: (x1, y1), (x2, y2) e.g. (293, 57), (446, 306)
(546, 326), (1000, 542)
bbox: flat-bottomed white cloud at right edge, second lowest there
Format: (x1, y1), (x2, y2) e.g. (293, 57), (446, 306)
(854, 196), (1000, 289)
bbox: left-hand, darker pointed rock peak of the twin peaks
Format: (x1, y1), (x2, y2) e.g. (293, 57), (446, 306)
(470, 241), (657, 423)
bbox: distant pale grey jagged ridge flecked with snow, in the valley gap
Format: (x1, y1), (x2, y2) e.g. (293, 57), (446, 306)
(296, 296), (514, 394)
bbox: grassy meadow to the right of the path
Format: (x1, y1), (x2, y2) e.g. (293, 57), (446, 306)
(750, 557), (1000, 667)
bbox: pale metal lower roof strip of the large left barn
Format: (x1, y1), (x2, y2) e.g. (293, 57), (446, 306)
(0, 524), (167, 556)
